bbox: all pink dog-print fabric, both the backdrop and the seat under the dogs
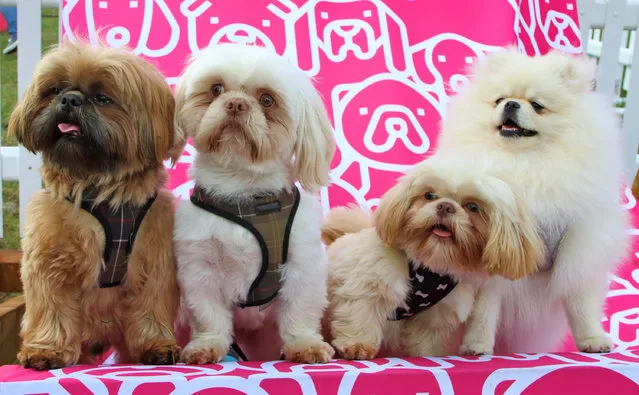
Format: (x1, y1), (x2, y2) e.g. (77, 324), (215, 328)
(0, 0), (639, 395)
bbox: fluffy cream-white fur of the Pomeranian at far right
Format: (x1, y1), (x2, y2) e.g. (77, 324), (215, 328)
(438, 50), (628, 354)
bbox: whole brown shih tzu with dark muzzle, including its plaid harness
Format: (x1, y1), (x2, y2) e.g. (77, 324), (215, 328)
(9, 43), (185, 370)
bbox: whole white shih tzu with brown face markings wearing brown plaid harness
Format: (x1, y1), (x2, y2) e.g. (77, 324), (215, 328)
(174, 44), (335, 364)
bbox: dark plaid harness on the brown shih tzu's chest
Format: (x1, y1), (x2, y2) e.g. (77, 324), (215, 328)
(68, 193), (157, 288)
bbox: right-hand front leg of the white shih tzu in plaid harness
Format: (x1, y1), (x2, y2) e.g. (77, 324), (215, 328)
(278, 249), (335, 363)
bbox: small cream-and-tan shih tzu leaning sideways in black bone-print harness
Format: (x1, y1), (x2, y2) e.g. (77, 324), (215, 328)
(322, 156), (544, 359)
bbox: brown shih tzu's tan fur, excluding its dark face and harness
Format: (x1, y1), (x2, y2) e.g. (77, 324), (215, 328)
(9, 43), (184, 369)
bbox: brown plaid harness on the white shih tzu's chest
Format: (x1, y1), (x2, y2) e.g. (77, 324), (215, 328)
(191, 185), (300, 307)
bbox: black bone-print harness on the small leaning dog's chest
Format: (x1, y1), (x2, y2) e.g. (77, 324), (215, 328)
(388, 261), (457, 321)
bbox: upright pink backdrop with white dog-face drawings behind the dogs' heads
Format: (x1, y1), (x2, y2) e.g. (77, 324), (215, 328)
(62, 0), (580, 208)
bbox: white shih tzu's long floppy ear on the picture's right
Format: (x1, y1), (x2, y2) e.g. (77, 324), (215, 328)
(295, 80), (335, 192)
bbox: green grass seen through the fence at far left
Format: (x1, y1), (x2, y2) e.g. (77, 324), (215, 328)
(0, 9), (58, 249)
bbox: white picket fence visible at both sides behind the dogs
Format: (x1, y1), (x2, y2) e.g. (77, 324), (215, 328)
(0, 0), (639, 241)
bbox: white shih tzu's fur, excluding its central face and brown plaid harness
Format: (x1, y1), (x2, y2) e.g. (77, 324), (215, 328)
(174, 44), (334, 363)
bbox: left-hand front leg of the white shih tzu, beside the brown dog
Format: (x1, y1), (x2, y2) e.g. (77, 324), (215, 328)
(176, 241), (233, 364)
